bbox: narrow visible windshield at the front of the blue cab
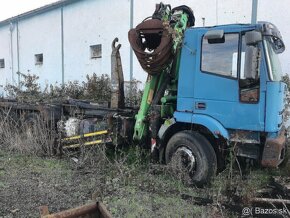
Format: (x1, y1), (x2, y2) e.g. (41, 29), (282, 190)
(264, 36), (282, 81)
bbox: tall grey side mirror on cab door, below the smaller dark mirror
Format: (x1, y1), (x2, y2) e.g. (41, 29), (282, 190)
(244, 46), (261, 80)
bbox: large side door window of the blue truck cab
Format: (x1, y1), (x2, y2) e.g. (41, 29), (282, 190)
(201, 33), (239, 78)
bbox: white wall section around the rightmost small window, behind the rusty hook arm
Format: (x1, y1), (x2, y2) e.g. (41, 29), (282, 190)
(64, 0), (130, 81)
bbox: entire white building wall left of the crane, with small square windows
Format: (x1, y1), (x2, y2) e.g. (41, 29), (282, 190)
(0, 0), (130, 94)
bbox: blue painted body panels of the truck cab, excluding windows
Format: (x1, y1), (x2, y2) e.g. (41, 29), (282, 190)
(174, 24), (286, 139)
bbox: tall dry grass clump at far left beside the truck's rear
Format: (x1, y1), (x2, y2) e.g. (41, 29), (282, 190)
(0, 110), (57, 156)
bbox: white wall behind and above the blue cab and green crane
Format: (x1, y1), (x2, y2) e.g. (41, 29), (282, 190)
(134, 0), (290, 81)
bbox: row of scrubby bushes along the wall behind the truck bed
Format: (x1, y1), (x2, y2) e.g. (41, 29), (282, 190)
(5, 73), (142, 106)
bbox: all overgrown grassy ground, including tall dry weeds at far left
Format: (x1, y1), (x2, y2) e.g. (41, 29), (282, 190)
(0, 105), (289, 217)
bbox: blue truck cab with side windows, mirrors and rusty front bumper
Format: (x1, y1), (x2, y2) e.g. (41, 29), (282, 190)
(164, 22), (287, 184)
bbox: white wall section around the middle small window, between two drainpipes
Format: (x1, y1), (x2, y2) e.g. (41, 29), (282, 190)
(14, 10), (62, 86)
